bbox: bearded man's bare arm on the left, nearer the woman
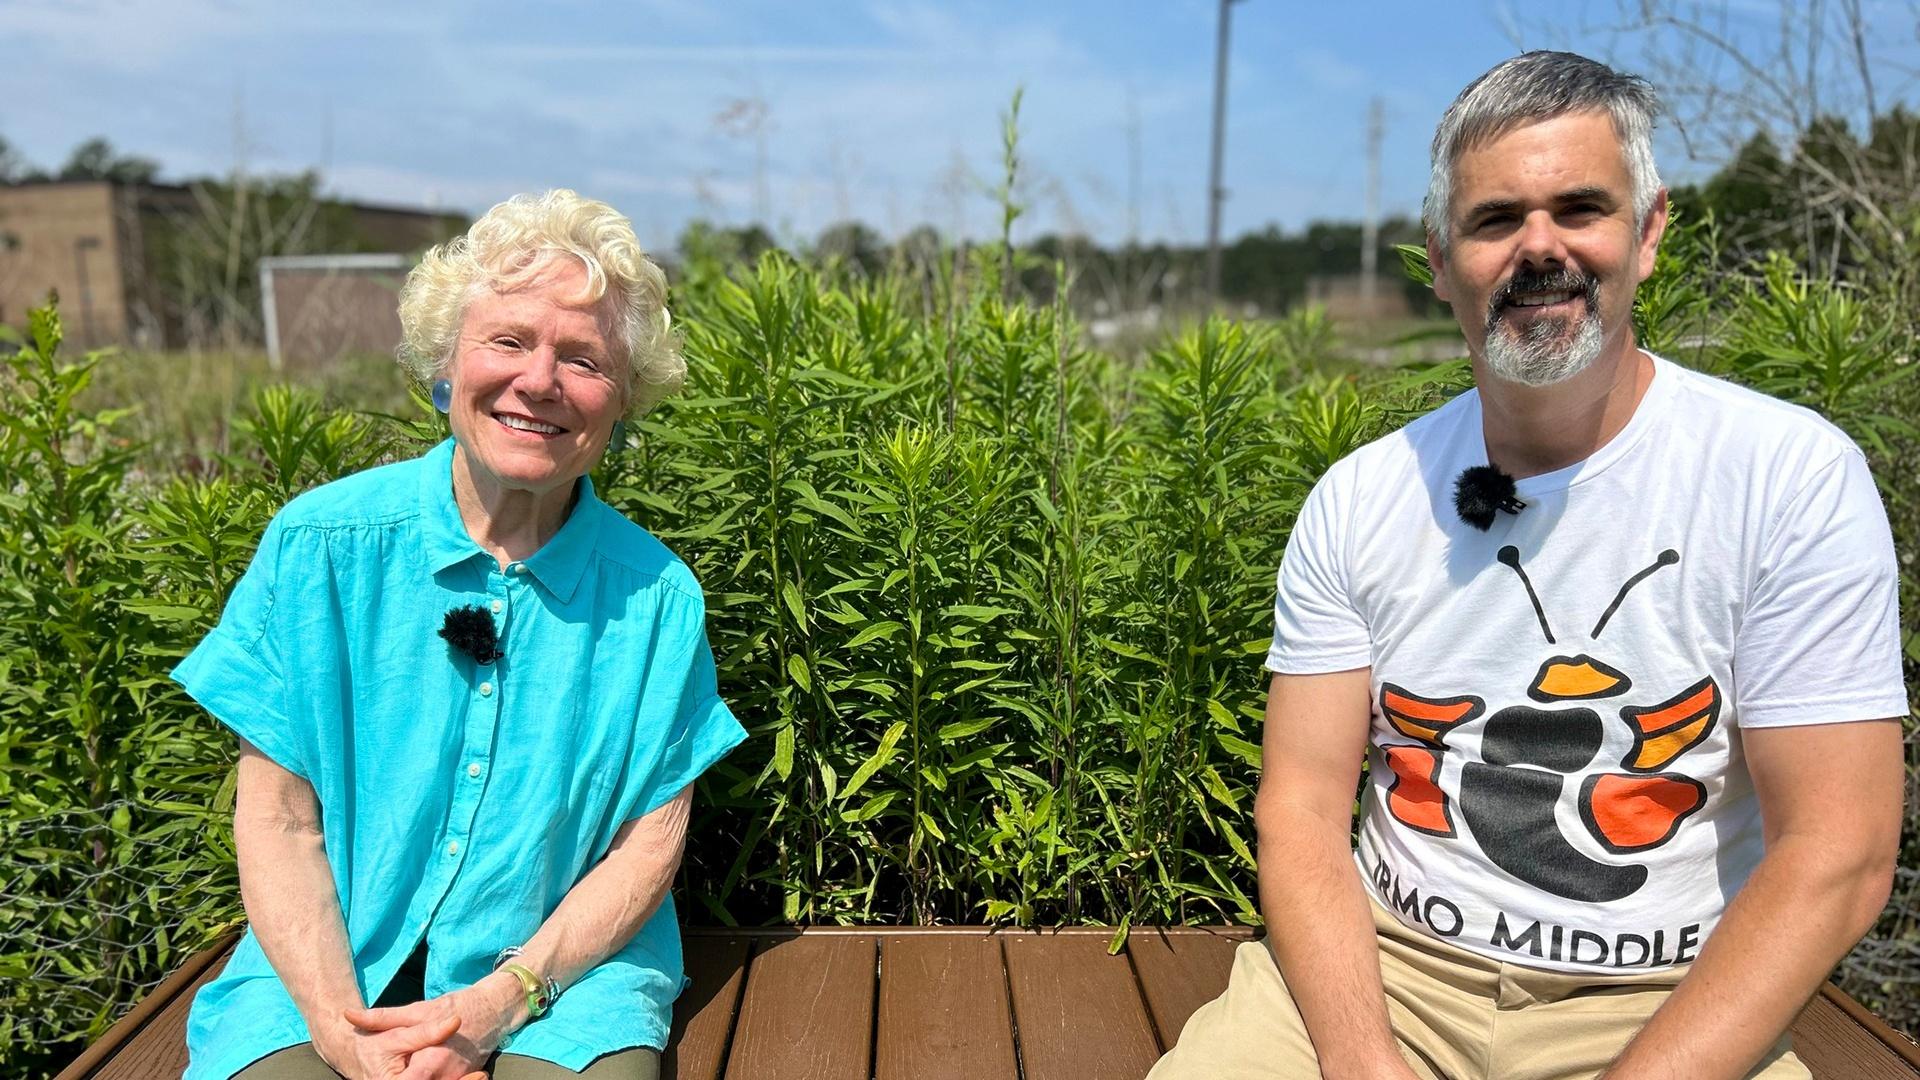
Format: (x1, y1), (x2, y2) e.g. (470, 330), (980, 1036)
(1254, 669), (1413, 1080)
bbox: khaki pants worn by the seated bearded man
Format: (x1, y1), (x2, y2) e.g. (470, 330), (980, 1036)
(1148, 905), (1811, 1080)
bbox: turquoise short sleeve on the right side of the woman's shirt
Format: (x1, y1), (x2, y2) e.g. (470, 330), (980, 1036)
(616, 588), (747, 821)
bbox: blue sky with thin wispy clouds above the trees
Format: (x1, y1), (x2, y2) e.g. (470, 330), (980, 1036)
(0, 0), (1916, 246)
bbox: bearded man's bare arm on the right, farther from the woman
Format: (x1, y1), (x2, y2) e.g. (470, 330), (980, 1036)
(1607, 721), (1905, 1080)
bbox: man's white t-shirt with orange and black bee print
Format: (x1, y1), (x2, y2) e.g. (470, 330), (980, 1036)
(1267, 349), (1907, 972)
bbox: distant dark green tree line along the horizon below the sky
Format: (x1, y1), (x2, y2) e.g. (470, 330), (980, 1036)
(0, 106), (1920, 338)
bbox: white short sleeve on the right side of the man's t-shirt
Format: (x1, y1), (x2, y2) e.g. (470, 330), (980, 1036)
(1734, 448), (1907, 728)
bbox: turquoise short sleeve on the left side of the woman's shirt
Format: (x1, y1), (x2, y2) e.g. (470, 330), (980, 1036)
(173, 517), (311, 778)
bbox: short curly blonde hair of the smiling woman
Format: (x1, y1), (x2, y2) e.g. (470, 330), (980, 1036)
(399, 188), (687, 415)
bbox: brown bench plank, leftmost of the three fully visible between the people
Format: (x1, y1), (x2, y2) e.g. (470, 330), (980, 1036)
(726, 934), (877, 1080)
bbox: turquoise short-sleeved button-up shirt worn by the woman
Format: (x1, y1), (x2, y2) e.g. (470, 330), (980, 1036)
(173, 440), (745, 1080)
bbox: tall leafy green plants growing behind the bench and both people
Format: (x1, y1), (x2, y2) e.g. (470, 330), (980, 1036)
(0, 223), (1920, 1072)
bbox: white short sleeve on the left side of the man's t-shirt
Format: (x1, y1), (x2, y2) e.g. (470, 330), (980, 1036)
(1267, 465), (1373, 675)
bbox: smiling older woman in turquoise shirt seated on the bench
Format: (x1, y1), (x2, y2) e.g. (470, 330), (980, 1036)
(175, 190), (743, 1080)
